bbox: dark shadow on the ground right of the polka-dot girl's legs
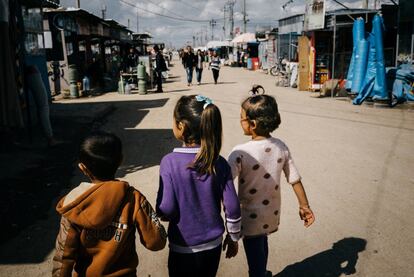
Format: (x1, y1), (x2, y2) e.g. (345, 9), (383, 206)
(274, 237), (367, 277)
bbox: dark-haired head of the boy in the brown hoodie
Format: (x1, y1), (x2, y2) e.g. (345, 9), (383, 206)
(79, 132), (122, 181)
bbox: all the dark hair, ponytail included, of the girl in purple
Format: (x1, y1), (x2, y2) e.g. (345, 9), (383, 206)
(174, 95), (222, 174)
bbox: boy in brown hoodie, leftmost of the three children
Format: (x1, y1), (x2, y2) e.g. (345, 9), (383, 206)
(53, 133), (166, 277)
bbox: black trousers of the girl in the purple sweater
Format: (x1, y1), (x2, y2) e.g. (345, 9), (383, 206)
(168, 244), (221, 277)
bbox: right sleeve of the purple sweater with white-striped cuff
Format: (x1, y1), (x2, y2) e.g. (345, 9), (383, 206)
(223, 167), (241, 241)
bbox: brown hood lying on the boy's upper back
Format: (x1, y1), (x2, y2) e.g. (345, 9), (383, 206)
(56, 181), (129, 229)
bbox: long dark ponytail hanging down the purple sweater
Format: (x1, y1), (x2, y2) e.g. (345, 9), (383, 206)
(194, 104), (223, 175)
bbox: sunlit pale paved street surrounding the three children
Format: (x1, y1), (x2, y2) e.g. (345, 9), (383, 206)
(0, 61), (414, 277)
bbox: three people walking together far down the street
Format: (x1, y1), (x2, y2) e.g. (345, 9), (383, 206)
(180, 46), (221, 86)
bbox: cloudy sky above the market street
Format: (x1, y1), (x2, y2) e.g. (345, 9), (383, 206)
(60, 0), (389, 47)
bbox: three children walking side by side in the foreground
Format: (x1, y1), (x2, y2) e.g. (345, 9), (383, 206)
(53, 86), (314, 277)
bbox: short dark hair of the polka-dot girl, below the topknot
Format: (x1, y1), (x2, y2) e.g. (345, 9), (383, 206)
(242, 94), (281, 136)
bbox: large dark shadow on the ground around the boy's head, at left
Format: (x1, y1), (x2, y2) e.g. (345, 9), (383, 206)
(0, 99), (175, 264)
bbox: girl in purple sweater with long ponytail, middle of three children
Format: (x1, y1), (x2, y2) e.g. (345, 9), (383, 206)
(156, 95), (241, 277)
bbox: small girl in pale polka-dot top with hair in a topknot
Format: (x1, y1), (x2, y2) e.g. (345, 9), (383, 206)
(228, 88), (315, 277)
